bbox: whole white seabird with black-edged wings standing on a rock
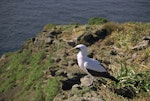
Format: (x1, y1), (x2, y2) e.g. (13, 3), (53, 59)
(71, 44), (119, 82)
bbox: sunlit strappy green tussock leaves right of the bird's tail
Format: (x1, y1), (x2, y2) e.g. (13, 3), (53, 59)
(117, 64), (150, 93)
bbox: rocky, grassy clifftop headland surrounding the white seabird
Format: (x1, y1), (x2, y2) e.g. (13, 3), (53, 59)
(0, 22), (150, 101)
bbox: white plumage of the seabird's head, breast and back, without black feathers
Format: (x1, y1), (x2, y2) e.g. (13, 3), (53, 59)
(75, 44), (107, 74)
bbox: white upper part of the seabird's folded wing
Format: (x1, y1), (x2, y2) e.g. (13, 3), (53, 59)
(84, 58), (107, 72)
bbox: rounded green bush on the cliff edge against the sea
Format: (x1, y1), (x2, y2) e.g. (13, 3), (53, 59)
(88, 17), (108, 25)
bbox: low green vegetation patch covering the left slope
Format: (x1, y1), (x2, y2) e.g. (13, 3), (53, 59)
(0, 49), (59, 101)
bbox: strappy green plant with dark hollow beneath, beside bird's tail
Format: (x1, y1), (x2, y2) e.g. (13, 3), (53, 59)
(115, 64), (150, 98)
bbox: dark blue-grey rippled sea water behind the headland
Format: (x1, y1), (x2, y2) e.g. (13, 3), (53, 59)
(0, 0), (150, 55)
